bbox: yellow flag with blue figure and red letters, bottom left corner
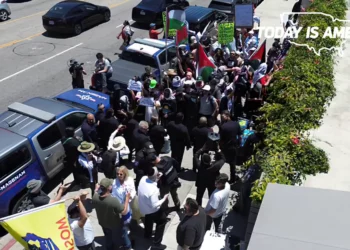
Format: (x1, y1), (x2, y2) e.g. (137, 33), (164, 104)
(0, 201), (74, 250)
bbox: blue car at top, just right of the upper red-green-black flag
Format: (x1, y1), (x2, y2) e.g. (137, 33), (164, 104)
(185, 6), (228, 34)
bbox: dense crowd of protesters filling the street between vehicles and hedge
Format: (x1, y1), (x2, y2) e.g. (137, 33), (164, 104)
(23, 2), (297, 250)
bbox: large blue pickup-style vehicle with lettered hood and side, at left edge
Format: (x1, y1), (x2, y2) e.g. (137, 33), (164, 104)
(0, 89), (110, 217)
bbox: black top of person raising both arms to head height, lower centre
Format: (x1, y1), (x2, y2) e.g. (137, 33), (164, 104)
(194, 149), (226, 186)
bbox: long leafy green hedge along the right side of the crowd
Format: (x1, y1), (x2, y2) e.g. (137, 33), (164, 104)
(251, 0), (346, 202)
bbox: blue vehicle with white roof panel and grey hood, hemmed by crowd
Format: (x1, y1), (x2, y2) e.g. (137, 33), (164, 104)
(108, 38), (176, 90)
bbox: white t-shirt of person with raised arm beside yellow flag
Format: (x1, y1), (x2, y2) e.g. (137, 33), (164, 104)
(68, 218), (95, 247)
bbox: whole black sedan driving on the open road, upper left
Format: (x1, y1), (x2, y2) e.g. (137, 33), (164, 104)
(43, 1), (111, 35)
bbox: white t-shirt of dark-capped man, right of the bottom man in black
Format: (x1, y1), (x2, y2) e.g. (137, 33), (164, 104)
(205, 183), (231, 218)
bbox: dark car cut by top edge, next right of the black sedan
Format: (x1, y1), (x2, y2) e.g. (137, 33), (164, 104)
(132, 0), (190, 25)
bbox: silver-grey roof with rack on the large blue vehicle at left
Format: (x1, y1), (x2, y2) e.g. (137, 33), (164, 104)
(0, 97), (74, 137)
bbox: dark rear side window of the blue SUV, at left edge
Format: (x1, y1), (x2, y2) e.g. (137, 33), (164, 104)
(0, 146), (32, 180)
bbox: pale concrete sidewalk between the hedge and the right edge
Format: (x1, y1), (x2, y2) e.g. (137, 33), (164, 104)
(304, 11), (350, 191)
